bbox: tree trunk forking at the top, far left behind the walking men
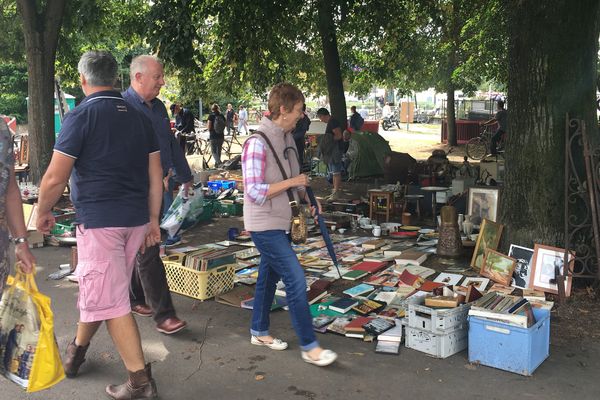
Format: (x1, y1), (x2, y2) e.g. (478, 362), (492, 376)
(17, 0), (66, 182)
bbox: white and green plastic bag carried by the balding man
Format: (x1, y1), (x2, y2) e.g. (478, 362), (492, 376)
(160, 186), (204, 236)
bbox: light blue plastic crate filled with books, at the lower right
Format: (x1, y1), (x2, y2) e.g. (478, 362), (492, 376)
(469, 308), (550, 376)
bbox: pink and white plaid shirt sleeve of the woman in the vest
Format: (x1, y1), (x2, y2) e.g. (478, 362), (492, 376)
(242, 137), (270, 206)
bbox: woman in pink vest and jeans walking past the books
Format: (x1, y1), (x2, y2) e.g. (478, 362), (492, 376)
(242, 83), (337, 366)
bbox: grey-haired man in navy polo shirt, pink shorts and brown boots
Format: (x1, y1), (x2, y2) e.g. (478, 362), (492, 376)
(37, 51), (162, 399)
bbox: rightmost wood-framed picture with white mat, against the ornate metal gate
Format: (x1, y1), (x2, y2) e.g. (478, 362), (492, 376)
(531, 243), (575, 297)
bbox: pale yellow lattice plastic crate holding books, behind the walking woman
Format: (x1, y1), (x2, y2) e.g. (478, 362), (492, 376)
(163, 261), (235, 301)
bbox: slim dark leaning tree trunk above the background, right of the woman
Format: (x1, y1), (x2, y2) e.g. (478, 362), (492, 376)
(317, 0), (347, 129)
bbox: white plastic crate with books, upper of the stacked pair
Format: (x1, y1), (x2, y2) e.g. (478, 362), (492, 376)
(407, 299), (471, 334)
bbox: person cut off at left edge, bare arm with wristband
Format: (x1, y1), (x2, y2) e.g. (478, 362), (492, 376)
(0, 118), (35, 293)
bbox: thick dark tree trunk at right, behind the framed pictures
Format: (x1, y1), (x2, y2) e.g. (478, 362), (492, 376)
(500, 0), (599, 247)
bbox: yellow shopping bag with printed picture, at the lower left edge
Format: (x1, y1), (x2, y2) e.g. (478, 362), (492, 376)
(0, 264), (65, 392)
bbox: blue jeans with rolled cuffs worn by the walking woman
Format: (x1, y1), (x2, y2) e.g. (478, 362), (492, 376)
(250, 230), (319, 351)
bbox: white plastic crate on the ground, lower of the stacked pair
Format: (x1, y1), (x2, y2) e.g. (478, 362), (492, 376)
(404, 325), (469, 358)
